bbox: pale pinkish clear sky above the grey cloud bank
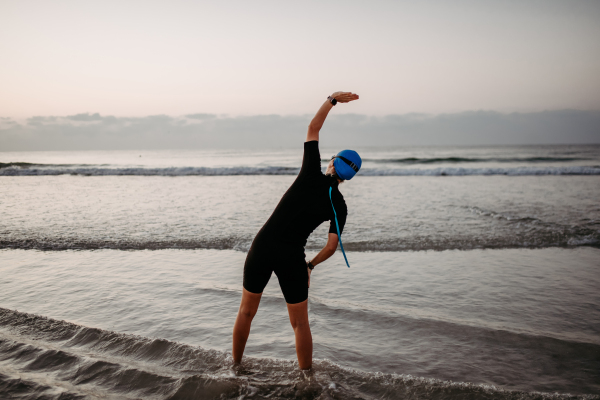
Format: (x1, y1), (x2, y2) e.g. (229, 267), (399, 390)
(0, 0), (600, 150)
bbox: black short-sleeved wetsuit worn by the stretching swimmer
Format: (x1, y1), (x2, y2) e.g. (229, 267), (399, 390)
(244, 140), (348, 304)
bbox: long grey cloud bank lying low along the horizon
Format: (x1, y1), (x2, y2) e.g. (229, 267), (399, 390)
(0, 110), (600, 151)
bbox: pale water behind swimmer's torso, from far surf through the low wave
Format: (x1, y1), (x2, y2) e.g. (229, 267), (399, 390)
(0, 175), (600, 251)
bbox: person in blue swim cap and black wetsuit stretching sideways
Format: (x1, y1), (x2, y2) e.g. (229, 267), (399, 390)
(233, 92), (361, 370)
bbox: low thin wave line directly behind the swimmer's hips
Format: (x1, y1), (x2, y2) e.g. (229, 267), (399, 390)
(0, 225), (600, 252)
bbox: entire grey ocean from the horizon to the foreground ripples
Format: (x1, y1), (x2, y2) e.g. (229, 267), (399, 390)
(0, 143), (600, 399)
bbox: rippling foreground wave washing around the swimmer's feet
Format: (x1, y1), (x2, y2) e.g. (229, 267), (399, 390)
(0, 308), (600, 400)
